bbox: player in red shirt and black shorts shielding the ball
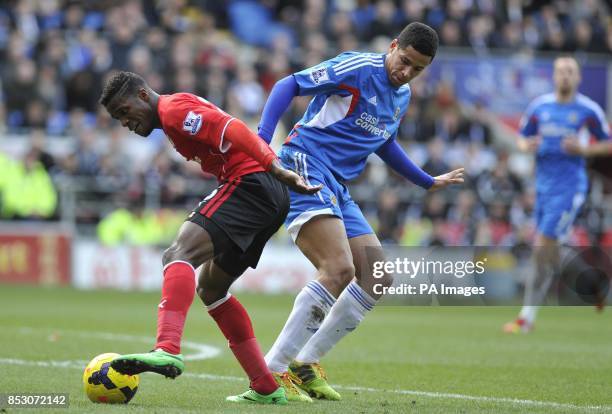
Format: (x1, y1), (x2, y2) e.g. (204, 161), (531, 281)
(100, 72), (320, 404)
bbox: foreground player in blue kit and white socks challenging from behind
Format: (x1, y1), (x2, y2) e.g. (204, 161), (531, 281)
(259, 23), (463, 401)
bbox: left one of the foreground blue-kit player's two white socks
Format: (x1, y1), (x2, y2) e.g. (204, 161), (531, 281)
(266, 280), (336, 372)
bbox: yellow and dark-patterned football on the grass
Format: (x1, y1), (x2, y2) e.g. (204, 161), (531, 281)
(83, 353), (140, 404)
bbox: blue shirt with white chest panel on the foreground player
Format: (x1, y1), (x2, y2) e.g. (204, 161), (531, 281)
(285, 52), (411, 180)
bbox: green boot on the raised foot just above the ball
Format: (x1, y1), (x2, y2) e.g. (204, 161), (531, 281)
(111, 349), (185, 379)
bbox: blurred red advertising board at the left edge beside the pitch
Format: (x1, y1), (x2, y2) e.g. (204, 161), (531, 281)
(0, 233), (71, 285)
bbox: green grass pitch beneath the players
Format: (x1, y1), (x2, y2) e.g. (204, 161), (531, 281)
(0, 285), (612, 414)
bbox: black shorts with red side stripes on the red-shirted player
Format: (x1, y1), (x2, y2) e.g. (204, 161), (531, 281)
(188, 172), (289, 277)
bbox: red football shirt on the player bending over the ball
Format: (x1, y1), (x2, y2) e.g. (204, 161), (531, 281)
(157, 93), (265, 181)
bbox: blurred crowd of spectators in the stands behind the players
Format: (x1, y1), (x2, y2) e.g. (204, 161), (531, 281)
(0, 0), (612, 246)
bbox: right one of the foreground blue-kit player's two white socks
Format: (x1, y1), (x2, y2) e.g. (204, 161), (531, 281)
(295, 281), (376, 363)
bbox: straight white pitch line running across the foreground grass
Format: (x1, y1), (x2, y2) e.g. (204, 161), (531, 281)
(0, 358), (612, 411)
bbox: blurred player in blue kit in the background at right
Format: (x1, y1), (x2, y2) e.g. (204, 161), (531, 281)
(504, 56), (612, 333)
